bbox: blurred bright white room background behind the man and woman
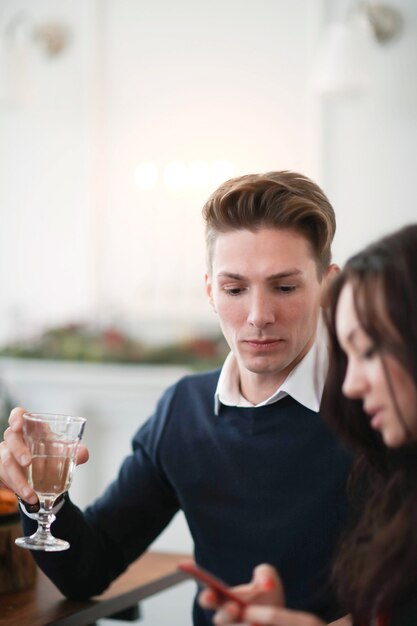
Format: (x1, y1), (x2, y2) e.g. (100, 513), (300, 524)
(0, 0), (417, 624)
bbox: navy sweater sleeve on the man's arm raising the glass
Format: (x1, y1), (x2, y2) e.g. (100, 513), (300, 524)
(23, 392), (179, 599)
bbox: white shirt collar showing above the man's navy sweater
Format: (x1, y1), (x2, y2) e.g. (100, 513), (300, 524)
(214, 318), (328, 415)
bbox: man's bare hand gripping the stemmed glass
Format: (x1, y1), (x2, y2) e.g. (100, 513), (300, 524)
(0, 407), (88, 504)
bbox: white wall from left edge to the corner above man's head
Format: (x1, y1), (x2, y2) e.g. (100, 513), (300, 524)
(0, 0), (321, 340)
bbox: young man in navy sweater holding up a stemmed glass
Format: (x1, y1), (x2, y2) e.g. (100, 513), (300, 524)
(0, 172), (350, 626)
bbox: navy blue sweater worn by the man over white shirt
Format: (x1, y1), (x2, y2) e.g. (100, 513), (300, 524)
(25, 370), (350, 626)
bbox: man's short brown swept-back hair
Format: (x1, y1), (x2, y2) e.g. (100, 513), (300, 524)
(203, 171), (336, 277)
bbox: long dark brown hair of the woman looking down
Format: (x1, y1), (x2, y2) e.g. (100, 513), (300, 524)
(322, 224), (417, 623)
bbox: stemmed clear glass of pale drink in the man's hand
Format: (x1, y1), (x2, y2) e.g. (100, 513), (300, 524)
(15, 413), (86, 552)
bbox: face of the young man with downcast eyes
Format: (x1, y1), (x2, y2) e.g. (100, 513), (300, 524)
(206, 228), (332, 402)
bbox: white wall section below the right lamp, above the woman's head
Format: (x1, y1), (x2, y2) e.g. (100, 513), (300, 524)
(321, 0), (417, 262)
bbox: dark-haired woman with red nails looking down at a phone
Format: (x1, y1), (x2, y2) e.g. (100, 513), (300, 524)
(200, 224), (417, 626)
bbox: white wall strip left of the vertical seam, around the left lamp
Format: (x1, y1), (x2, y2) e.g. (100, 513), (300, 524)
(0, 0), (94, 338)
